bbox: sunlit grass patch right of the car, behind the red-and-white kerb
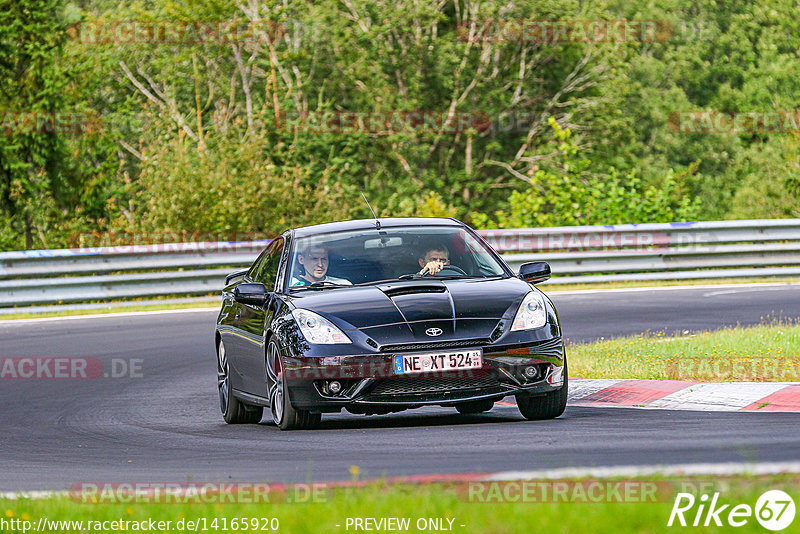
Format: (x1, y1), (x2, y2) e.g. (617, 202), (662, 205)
(568, 321), (800, 382)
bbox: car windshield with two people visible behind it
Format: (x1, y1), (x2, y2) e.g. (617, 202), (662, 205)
(288, 226), (506, 290)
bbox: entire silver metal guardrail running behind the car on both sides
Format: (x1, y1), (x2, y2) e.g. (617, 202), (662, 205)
(0, 219), (800, 311)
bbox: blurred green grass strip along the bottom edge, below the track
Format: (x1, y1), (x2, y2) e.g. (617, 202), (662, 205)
(0, 474), (800, 534)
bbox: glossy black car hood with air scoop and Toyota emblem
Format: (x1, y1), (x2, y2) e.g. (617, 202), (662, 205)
(292, 278), (531, 344)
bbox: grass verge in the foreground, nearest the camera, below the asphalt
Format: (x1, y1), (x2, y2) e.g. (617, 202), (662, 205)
(0, 474), (800, 534)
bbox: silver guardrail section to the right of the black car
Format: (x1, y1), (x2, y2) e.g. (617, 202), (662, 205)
(490, 219), (800, 284)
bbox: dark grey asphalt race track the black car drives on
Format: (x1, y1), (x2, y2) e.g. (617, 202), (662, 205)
(0, 285), (800, 490)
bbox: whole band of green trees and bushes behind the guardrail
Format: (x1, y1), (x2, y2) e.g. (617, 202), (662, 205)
(0, 0), (800, 249)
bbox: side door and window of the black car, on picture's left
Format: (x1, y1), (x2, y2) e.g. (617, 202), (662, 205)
(238, 237), (284, 396)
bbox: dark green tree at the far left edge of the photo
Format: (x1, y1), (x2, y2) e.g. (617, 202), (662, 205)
(0, 0), (76, 248)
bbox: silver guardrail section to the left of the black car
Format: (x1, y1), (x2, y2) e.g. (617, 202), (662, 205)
(0, 240), (269, 310)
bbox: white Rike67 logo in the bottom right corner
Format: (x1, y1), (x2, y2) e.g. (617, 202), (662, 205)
(667, 490), (795, 531)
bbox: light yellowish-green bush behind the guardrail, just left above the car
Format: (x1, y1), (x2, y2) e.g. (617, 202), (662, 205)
(129, 134), (361, 233)
